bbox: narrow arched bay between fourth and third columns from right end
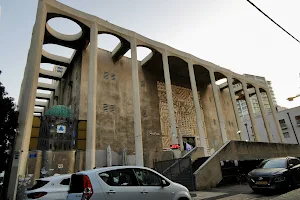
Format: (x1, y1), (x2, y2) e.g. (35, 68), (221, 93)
(232, 78), (255, 141)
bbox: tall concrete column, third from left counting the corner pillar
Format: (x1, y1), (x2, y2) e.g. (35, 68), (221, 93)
(130, 38), (144, 166)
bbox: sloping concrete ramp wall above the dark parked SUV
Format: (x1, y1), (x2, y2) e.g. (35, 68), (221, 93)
(194, 141), (300, 190)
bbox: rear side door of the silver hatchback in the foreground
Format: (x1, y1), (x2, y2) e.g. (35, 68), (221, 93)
(95, 168), (140, 200)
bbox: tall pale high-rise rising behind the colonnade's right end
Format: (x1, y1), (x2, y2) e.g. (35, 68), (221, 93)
(235, 74), (277, 117)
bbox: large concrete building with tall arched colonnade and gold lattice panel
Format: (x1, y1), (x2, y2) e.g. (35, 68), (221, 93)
(9, 0), (284, 197)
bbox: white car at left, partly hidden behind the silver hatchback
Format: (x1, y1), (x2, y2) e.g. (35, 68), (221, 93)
(25, 174), (71, 200)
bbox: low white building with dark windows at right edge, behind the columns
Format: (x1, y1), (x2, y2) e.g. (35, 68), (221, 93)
(242, 106), (300, 144)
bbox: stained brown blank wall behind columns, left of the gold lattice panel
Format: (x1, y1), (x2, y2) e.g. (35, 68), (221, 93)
(79, 48), (162, 166)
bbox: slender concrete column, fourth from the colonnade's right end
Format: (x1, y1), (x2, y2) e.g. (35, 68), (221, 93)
(227, 77), (248, 140)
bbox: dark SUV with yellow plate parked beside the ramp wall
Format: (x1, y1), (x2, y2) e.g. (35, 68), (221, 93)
(247, 157), (300, 192)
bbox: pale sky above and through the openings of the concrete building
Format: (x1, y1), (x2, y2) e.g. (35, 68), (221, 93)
(0, 0), (300, 108)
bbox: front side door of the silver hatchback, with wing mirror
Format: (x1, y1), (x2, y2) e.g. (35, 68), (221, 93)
(134, 168), (176, 200)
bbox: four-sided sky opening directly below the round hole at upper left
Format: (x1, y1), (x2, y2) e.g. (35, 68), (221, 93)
(43, 44), (75, 59)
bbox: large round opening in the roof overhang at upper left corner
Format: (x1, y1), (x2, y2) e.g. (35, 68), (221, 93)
(47, 17), (82, 36)
